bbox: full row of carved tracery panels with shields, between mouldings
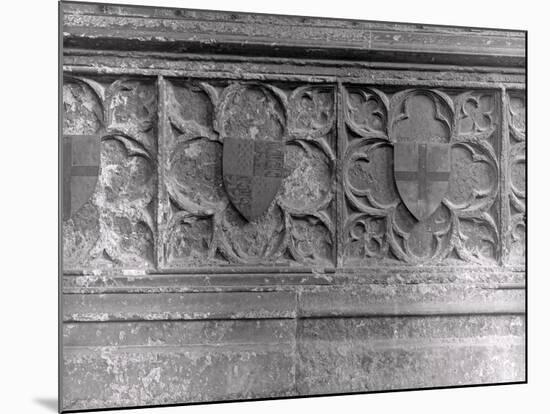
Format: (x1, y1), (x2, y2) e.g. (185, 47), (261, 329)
(64, 77), (525, 269)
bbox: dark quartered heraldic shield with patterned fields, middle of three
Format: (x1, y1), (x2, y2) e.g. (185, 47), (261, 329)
(223, 137), (284, 221)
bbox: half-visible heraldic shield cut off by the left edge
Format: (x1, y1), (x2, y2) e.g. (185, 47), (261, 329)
(63, 135), (100, 220)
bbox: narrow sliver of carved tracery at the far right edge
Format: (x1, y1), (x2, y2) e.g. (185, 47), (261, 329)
(506, 91), (526, 264)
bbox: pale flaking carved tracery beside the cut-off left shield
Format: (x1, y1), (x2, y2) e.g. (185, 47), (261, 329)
(63, 76), (157, 270)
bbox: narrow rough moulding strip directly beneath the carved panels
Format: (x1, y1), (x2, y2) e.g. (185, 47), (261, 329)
(62, 268), (525, 294)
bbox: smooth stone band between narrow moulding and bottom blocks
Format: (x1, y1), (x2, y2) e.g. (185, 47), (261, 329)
(63, 284), (525, 322)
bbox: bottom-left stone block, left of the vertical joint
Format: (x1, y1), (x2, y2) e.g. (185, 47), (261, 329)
(63, 320), (296, 410)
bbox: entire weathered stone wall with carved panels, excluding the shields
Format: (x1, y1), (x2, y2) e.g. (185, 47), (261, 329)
(61, 3), (526, 410)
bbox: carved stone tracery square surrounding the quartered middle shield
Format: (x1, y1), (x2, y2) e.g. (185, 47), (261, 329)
(159, 80), (335, 268)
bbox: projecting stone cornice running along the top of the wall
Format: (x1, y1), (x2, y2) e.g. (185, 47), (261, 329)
(62, 2), (525, 66)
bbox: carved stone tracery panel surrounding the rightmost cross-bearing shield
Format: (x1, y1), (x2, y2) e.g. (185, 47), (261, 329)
(342, 86), (499, 265)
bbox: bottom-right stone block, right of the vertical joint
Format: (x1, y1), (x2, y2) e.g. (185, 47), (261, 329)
(296, 316), (525, 394)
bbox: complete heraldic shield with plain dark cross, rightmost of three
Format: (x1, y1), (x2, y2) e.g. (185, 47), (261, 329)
(394, 142), (451, 221)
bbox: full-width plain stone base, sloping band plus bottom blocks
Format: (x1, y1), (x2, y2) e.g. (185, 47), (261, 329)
(63, 283), (525, 410)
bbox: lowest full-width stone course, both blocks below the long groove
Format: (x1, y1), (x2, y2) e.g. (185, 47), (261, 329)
(63, 315), (525, 409)
